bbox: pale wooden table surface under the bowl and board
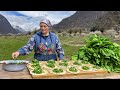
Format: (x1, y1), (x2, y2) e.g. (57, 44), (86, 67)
(0, 64), (120, 79)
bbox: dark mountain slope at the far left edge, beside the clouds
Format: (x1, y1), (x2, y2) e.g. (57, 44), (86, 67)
(0, 14), (21, 34)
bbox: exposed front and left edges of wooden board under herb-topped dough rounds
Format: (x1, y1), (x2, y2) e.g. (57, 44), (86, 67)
(27, 60), (108, 79)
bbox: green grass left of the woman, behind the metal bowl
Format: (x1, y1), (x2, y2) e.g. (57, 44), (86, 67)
(0, 36), (33, 60)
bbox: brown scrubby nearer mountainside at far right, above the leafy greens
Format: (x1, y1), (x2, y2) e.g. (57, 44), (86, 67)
(93, 11), (120, 30)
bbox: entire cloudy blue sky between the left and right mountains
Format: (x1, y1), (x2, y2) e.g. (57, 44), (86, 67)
(0, 11), (76, 31)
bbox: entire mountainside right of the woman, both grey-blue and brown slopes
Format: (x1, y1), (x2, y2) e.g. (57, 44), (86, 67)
(53, 11), (120, 30)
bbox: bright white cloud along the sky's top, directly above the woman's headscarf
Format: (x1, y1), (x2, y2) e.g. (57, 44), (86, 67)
(17, 11), (76, 24)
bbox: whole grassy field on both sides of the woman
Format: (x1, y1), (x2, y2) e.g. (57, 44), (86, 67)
(0, 35), (82, 60)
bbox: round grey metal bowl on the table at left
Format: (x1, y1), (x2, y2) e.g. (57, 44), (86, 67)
(2, 60), (27, 72)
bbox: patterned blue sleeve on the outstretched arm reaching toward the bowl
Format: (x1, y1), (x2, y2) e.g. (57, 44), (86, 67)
(18, 36), (35, 55)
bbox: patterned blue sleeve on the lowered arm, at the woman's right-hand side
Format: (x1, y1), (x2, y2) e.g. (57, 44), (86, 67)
(56, 37), (64, 60)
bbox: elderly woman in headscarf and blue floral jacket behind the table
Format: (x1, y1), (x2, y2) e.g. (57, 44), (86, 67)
(12, 19), (64, 61)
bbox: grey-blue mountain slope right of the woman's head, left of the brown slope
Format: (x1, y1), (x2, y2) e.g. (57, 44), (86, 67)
(53, 11), (107, 29)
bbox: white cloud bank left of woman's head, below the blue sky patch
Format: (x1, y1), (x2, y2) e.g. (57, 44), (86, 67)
(4, 15), (39, 31)
